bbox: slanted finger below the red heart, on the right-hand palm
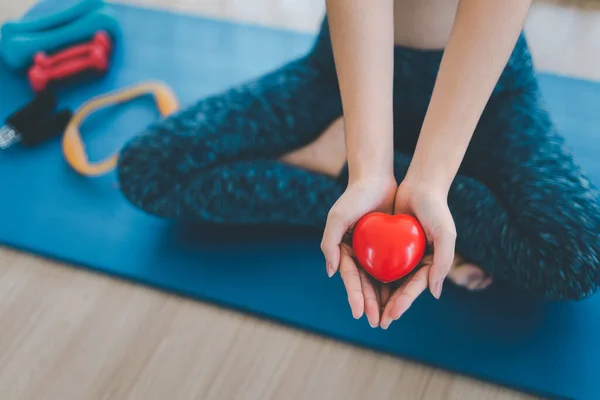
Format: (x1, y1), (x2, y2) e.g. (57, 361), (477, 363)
(381, 265), (430, 329)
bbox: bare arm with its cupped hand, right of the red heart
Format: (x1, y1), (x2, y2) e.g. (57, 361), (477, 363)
(390, 0), (531, 312)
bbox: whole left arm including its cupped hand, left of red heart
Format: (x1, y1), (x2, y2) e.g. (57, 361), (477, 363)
(321, 0), (398, 326)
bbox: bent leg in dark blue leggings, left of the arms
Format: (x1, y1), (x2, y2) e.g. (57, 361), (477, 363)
(118, 57), (343, 226)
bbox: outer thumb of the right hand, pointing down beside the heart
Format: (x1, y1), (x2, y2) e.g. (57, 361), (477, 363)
(429, 223), (456, 299)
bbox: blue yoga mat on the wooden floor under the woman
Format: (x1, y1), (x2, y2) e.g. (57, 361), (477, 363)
(0, 1), (600, 400)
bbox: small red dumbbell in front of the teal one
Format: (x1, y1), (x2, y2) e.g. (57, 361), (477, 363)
(29, 31), (112, 92)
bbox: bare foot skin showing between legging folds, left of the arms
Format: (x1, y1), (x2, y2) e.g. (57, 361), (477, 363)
(281, 118), (346, 178)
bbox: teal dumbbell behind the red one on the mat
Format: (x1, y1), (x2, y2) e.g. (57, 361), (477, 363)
(0, 0), (121, 70)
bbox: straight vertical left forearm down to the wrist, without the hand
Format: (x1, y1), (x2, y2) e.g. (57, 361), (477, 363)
(326, 0), (394, 181)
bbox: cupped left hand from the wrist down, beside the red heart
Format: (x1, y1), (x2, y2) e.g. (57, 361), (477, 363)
(321, 175), (398, 327)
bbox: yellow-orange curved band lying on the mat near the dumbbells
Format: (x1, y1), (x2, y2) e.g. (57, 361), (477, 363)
(62, 82), (179, 176)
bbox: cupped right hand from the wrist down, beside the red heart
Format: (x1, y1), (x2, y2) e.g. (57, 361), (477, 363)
(380, 180), (456, 329)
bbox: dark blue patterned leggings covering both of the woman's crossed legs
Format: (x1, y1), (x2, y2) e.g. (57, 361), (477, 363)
(118, 20), (600, 300)
